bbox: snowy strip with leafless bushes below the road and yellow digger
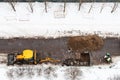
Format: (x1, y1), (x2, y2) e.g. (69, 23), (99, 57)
(0, 56), (120, 80)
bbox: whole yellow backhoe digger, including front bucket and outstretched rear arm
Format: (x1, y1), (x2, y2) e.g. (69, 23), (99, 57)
(7, 49), (60, 66)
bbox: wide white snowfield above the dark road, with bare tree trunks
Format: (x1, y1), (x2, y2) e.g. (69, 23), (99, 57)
(0, 2), (120, 38)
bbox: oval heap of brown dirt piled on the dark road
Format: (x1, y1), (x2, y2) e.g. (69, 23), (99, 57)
(68, 35), (104, 52)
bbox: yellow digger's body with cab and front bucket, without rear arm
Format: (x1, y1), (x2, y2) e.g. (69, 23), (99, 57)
(7, 49), (36, 65)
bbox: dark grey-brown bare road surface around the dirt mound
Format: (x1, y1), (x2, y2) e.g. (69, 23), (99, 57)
(0, 37), (120, 64)
